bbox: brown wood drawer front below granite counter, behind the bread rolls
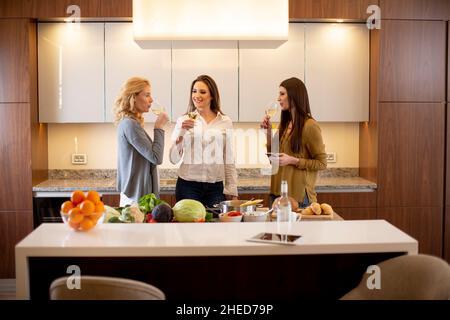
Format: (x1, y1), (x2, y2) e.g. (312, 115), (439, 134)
(317, 191), (377, 208)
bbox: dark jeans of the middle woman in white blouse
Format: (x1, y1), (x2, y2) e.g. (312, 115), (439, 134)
(175, 177), (225, 208)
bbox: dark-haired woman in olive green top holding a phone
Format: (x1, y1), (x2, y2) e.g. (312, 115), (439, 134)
(261, 78), (327, 207)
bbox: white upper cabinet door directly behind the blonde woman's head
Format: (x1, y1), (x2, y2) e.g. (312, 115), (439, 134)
(105, 22), (172, 122)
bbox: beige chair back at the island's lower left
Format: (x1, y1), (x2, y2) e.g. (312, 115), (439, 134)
(50, 276), (166, 300)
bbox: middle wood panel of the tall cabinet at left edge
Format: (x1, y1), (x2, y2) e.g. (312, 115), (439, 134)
(0, 103), (33, 211)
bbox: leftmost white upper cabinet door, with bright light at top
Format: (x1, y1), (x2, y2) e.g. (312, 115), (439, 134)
(38, 23), (105, 122)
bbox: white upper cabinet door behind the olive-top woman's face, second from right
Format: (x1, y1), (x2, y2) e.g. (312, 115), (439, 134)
(239, 23), (305, 122)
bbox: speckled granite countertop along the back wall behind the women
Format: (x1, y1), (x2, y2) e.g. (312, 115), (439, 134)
(33, 169), (377, 193)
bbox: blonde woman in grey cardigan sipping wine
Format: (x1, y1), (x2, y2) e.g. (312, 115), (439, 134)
(114, 77), (169, 206)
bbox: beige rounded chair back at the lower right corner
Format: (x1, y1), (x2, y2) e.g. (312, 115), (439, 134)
(341, 254), (450, 300)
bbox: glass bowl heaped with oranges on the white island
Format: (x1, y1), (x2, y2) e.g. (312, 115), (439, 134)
(60, 190), (105, 231)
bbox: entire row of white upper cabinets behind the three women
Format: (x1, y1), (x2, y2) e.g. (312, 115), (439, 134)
(38, 22), (369, 123)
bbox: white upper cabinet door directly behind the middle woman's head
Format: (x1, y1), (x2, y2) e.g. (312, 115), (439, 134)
(172, 41), (239, 121)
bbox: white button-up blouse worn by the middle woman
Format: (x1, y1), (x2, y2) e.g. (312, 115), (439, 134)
(170, 112), (238, 196)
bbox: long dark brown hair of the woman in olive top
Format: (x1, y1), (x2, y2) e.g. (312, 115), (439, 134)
(279, 78), (311, 153)
